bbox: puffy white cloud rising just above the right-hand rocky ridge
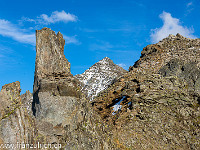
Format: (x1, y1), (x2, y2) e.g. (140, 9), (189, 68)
(150, 11), (196, 43)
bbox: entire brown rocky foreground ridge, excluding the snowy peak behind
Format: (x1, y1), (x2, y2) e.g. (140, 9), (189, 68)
(0, 28), (200, 150)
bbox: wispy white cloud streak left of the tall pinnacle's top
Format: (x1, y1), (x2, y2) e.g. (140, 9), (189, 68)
(0, 19), (35, 45)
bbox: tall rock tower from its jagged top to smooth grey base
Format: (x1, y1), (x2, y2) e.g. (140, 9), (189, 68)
(33, 28), (79, 125)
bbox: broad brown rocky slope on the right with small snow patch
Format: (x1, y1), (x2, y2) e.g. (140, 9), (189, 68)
(93, 34), (200, 149)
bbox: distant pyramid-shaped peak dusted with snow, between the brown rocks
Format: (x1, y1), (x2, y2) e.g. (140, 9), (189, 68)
(75, 57), (127, 100)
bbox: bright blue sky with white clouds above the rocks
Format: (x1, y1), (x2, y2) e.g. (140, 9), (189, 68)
(0, 0), (200, 93)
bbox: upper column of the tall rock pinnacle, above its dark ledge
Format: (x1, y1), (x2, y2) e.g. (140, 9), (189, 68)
(34, 28), (71, 92)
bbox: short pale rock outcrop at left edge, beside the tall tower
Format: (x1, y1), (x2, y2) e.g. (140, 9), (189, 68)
(0, 81), (39, 150)
